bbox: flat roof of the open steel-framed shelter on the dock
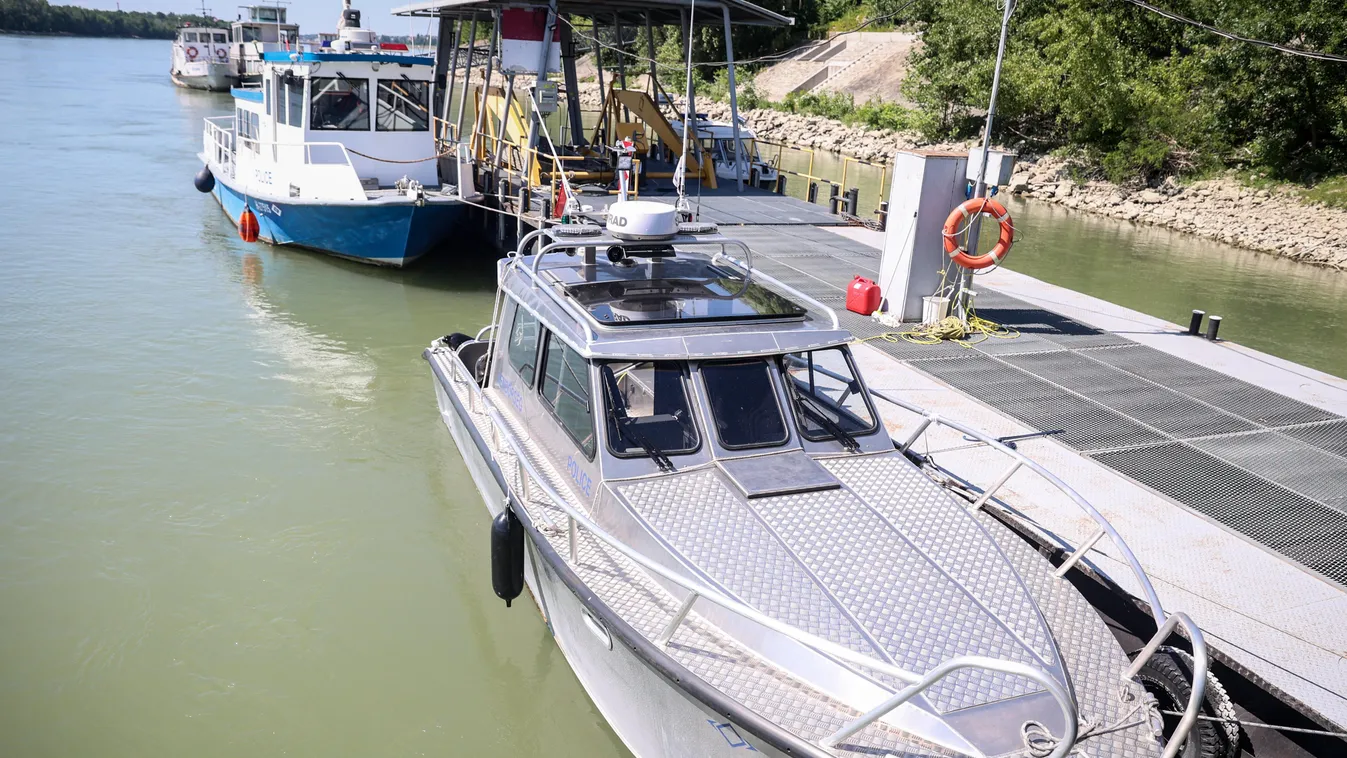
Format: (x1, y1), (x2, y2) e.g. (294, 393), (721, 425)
(393, 0), (795, 27)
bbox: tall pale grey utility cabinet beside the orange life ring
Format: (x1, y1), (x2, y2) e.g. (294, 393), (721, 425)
(880, 149), (975, 322)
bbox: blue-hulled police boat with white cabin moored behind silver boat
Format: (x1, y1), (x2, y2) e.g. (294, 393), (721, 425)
(197, 9), (465, 267)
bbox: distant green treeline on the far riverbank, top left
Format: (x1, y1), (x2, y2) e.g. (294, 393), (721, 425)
(0, 0), (222, 39)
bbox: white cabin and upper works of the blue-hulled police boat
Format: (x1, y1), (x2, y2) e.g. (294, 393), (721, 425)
(205, 51), (439, 201)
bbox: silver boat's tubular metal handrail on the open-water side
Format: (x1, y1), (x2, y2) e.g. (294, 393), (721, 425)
(430, 353), (1082, 758)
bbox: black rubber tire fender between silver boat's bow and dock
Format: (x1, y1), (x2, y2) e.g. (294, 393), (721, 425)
(1137, 645), (1239, 758)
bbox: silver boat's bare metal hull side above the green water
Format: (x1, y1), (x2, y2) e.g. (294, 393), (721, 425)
(432, 358), (787, 758)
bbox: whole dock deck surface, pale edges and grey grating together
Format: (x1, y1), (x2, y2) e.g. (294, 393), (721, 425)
(723, 218), (1347, 726)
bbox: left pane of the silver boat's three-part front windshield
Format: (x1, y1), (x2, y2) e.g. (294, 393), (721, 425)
(599, 361), (700, 470)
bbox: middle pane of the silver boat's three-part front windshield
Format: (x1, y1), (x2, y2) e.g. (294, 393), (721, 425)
(702, 359), (789, 450)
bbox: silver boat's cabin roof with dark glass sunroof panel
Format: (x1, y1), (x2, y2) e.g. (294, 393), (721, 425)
(501, 228), (851, 359)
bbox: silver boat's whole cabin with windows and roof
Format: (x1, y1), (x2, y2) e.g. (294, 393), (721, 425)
(486, 215), (893, 501)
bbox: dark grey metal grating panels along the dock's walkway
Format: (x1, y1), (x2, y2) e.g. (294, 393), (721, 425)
(734, 226), (1347, 586)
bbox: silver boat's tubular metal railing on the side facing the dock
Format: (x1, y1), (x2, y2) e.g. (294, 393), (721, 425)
(870, 389), (1210, 758)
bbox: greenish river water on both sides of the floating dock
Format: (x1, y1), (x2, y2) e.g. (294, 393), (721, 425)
(0, 31), (1347, 758)
